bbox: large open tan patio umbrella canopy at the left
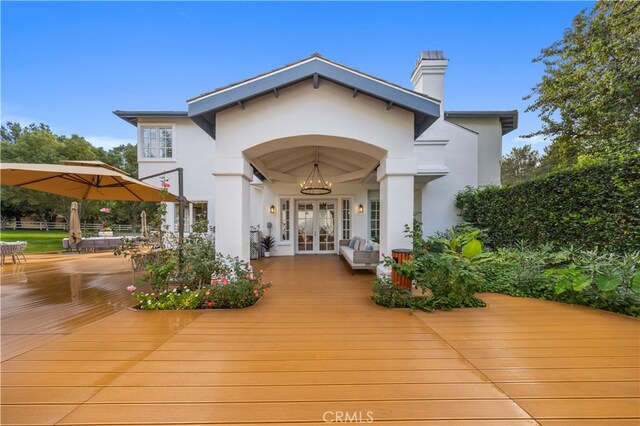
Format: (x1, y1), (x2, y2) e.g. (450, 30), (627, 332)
(0, 161), (178, 202)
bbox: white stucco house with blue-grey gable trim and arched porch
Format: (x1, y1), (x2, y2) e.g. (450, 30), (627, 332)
(114, 51), (518, 268)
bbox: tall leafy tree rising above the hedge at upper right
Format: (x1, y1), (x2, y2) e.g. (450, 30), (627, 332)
(524, 0), (640, 166)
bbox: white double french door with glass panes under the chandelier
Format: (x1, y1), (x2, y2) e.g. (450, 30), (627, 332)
(296, 200), (337, 254)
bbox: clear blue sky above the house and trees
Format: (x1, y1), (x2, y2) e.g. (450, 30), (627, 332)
(1, 1), (593, 153)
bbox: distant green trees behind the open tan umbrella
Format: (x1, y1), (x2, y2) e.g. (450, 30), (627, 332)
(0, 122), (157, 228)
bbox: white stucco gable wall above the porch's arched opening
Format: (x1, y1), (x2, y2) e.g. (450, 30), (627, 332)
(216, 80), (413, 158)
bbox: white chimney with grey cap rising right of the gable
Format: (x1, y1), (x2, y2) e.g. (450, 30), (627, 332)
(411, 50), (449, 105)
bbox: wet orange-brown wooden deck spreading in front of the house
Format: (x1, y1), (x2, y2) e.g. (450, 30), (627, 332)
(1, 255), (640, 426)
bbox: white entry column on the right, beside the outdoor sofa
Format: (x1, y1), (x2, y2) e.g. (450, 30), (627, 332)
(378, 158), (418, 256)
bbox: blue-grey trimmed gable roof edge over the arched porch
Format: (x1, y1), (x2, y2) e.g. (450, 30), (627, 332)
(187, 54), (440, 138)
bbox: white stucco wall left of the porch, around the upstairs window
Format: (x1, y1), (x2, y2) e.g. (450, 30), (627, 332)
(138, 118), (215, 231)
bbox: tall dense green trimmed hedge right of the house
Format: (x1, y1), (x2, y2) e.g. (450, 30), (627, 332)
(456, 156), (640, 253)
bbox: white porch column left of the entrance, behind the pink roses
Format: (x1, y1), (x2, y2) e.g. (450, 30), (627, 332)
(213, 158), (253, 261)
